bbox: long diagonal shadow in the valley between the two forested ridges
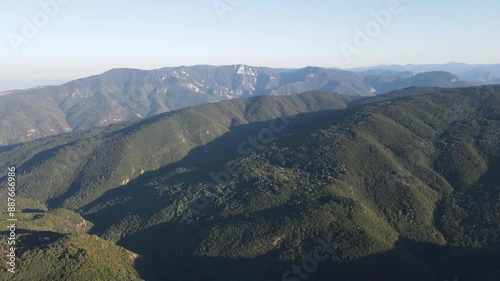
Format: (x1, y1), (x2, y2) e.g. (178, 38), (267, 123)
(82, 109), (354, 235)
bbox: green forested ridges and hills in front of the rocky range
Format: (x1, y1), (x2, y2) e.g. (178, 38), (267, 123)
(0, 86), (500, 281)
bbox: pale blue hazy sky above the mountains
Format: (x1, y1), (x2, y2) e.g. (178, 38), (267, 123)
(0, 0), (500, 80)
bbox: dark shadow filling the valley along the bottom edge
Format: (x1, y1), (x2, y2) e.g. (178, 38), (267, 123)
(115, 219), (500, 281)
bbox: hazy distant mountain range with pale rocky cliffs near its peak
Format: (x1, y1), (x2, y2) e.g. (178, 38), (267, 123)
(0, 65), (474, 146)
